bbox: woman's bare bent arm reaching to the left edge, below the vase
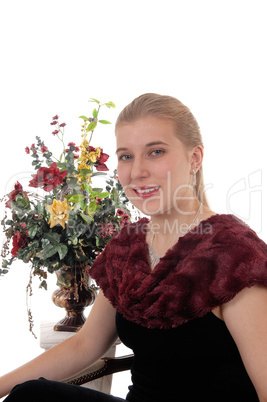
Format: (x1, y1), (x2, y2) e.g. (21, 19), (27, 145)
(0, 292), (117, 397)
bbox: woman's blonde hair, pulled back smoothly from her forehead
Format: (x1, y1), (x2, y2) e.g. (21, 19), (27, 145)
(115, 93), (209, 207)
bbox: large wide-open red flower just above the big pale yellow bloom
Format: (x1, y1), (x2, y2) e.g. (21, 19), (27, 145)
(29, 162), (68, 191)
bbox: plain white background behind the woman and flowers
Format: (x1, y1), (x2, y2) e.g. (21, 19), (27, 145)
(0, 0), (267, 396)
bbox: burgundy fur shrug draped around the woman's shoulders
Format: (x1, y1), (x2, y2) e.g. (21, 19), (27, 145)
(90, 215), (267, 328)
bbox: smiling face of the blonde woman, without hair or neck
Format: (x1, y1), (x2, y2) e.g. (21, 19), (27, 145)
(116, 116), (197, 215)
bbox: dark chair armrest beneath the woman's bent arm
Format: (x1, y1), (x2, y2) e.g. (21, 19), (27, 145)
(64, 355), (134, 385)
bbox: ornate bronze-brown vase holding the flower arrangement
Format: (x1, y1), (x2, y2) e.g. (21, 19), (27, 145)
(52, 265), (97, 332)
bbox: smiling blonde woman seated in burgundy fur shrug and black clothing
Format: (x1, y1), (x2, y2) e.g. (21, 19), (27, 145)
(0, 94), (267, 402)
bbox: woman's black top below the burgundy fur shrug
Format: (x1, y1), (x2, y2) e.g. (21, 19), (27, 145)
(116, 312), (259, 402)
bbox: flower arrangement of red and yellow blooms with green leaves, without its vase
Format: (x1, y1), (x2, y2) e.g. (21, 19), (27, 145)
(0, 99), (130, 288)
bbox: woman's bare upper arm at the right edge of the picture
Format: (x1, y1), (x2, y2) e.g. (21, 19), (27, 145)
(221, 285), (267, 402)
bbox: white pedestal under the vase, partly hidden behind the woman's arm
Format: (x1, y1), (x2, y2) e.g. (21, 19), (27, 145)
(40, 321), (116, 394)
